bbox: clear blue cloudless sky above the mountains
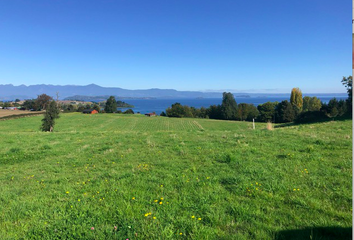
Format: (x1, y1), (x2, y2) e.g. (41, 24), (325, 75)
(0, 0), (352, 92)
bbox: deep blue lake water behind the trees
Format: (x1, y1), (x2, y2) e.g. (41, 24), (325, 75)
(119, 94), (348, 114)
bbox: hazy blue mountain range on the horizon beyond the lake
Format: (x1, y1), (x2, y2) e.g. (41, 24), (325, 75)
(0, 84), (345, 101)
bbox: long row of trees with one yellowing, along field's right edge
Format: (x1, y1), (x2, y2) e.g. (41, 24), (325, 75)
(161, 76), (352, 123)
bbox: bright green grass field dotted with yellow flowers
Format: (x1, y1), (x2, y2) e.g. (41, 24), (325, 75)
(0, 113), (352, 240)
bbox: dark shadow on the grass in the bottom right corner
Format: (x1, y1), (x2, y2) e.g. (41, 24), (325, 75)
(274, 227), (352, 240)
